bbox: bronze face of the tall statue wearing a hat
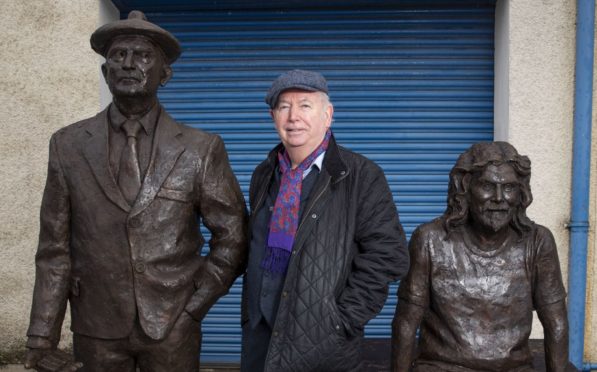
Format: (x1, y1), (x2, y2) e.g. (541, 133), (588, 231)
(102, 36), (172, 96)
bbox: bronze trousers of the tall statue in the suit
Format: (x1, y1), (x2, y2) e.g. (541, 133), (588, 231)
(73, 311), (201, 372)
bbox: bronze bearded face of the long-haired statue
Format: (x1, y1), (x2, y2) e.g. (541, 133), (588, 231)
(469, 164), (521, 232)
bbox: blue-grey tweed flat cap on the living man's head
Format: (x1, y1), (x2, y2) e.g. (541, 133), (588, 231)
(265, 70), (328, 109)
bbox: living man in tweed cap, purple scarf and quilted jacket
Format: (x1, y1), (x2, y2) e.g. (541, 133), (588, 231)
(241, 70), (408, 372)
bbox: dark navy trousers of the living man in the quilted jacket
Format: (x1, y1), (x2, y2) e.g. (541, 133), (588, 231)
(240, 317), (272, 372)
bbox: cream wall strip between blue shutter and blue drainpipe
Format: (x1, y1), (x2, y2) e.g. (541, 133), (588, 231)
(496, 0), (576, 338)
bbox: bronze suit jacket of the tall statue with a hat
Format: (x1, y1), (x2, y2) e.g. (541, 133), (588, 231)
(28, 108), (246, 341)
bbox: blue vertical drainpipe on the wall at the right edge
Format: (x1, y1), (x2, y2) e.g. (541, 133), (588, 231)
(568, 0), (595, 369)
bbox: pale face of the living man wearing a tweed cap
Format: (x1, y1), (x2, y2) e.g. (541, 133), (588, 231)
(270, 89), (334, 154)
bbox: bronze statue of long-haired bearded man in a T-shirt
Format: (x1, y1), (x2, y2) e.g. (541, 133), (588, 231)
(392, 142), (568, 371)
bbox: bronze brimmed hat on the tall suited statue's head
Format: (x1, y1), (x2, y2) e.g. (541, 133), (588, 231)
(90, 10), (181, 64)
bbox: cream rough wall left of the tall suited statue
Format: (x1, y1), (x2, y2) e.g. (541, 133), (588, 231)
(0, 0), (117, 364)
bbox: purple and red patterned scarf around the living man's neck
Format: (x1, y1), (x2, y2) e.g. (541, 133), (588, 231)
(261, 129), (332, 274)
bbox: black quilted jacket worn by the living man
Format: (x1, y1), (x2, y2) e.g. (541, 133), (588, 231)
(242, 137), (409, 372)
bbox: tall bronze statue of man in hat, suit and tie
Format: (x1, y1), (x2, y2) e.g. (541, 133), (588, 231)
(25, 11), (246, 372)
